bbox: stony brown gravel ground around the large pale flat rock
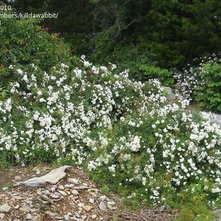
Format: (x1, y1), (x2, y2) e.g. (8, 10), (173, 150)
(0, 165), (175, 221)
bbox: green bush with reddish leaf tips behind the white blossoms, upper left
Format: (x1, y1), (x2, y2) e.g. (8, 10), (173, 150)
(0, 14), (70, 87)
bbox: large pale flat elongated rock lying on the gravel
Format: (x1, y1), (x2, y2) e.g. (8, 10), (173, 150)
(22, 166), (71, 187)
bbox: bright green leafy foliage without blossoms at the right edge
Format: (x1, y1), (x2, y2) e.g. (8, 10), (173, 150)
(195, 62), (221, 111)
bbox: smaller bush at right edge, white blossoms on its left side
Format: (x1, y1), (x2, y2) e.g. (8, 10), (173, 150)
(174, 56), (221, 111)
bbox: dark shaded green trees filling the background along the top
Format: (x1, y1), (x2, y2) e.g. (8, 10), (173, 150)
(7, 0), (221, 71)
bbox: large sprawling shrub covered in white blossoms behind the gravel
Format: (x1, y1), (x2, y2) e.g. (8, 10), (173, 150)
(0, 57), (221, 209)
